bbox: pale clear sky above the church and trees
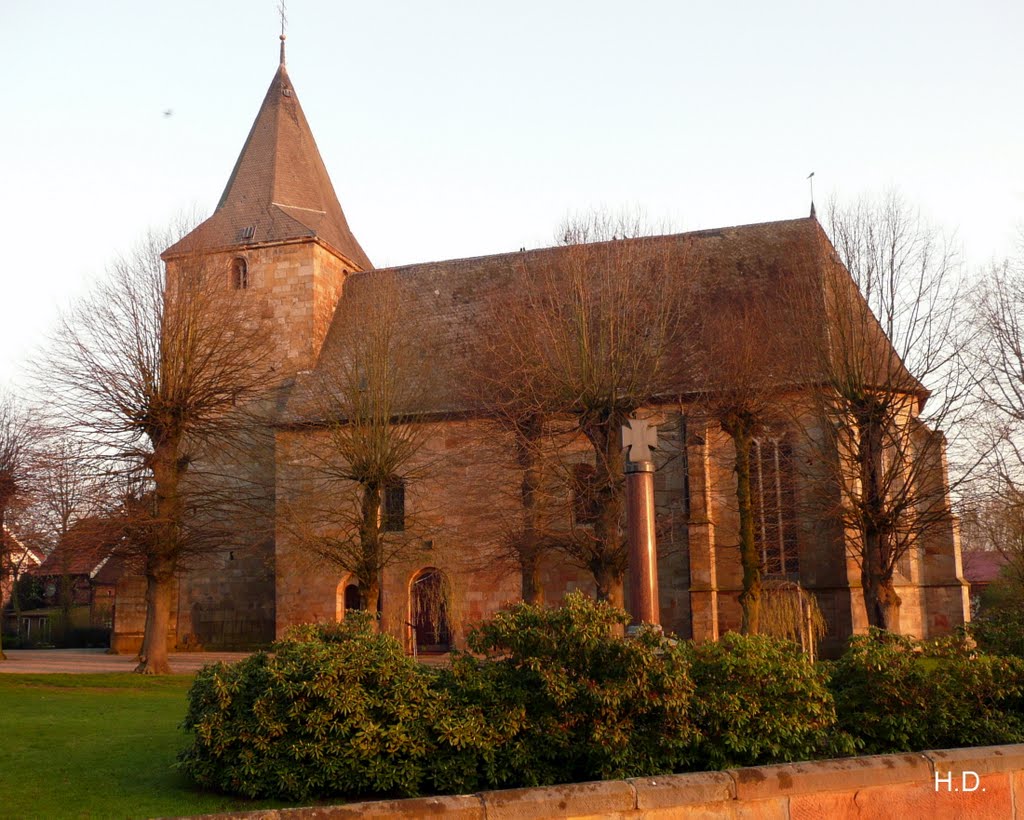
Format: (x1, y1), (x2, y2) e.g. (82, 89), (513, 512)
(0, 0), (1024, 383)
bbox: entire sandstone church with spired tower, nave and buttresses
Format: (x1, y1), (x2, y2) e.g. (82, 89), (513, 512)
(114, 43), (969, 651)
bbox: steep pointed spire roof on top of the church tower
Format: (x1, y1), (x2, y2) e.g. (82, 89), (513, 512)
(164, 51), (373, 270)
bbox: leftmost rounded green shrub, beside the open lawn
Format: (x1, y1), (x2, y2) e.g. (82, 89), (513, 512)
(178, 613), (430, 800)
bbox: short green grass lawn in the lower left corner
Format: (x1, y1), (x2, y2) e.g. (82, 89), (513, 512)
(0, 675), (286, 818)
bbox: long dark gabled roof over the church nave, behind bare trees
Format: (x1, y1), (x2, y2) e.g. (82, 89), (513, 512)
(281, 217), (927, 424)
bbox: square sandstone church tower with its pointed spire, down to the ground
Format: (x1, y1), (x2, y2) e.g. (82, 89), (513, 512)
(149, 41), (373, 649)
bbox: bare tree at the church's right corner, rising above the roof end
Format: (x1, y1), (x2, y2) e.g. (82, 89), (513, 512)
(803, 192), (970, 631)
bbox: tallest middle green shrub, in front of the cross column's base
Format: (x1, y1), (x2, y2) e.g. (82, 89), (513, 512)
(431, 593), (696, 791)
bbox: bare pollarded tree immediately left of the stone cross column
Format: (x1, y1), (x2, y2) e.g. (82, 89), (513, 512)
(475, 215), (688, 605)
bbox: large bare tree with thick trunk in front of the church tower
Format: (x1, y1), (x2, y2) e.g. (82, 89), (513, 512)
(39, 224), (268, 674)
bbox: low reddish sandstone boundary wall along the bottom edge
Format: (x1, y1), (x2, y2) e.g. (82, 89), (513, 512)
(192, 744), (1024, 820)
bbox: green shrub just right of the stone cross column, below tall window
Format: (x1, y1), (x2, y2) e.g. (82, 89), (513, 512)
(691, 633), (853, 769)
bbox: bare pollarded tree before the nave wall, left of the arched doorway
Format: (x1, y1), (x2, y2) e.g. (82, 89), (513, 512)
(281, 272), (430, 612)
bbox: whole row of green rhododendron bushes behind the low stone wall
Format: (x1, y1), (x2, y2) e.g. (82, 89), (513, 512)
(179, 594), (1024, 801)
